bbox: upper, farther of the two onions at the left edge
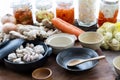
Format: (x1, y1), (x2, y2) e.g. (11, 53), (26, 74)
(1, 14), (16, 24)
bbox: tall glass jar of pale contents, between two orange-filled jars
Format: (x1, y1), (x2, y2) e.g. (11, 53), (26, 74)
(77, 0), (97, 27)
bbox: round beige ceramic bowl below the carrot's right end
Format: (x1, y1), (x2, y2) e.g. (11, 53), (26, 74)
(78, 32), (104, 50)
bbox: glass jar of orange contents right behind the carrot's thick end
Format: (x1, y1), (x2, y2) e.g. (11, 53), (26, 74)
(56, 0), (74, 24)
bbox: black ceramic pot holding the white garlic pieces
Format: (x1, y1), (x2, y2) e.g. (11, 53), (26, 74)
(4, 40), (52, 72)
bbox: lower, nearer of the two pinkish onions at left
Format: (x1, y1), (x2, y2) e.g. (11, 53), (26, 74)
(3, 23), (17, 34)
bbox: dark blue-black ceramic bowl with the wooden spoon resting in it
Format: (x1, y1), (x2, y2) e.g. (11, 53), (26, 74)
(56, 48), (98, 71)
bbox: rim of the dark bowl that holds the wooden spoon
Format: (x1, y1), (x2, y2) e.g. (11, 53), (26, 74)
(56, 48), (99, 71)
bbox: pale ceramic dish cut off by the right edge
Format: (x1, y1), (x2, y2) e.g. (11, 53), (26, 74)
(113, 56), (120, 75)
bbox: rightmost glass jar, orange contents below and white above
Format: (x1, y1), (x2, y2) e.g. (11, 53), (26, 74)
(98, 0), (119, 26)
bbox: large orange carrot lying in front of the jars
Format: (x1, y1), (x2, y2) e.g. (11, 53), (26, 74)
(52, 18), (85, 37)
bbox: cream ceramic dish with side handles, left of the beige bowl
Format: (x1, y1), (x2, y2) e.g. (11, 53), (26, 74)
(46, 33), (77, 54)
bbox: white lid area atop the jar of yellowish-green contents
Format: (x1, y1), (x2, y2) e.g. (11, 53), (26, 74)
(36, 0), (52, 10)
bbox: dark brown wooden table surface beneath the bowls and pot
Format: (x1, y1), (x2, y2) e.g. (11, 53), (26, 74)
(0, 21), (120, 80)
